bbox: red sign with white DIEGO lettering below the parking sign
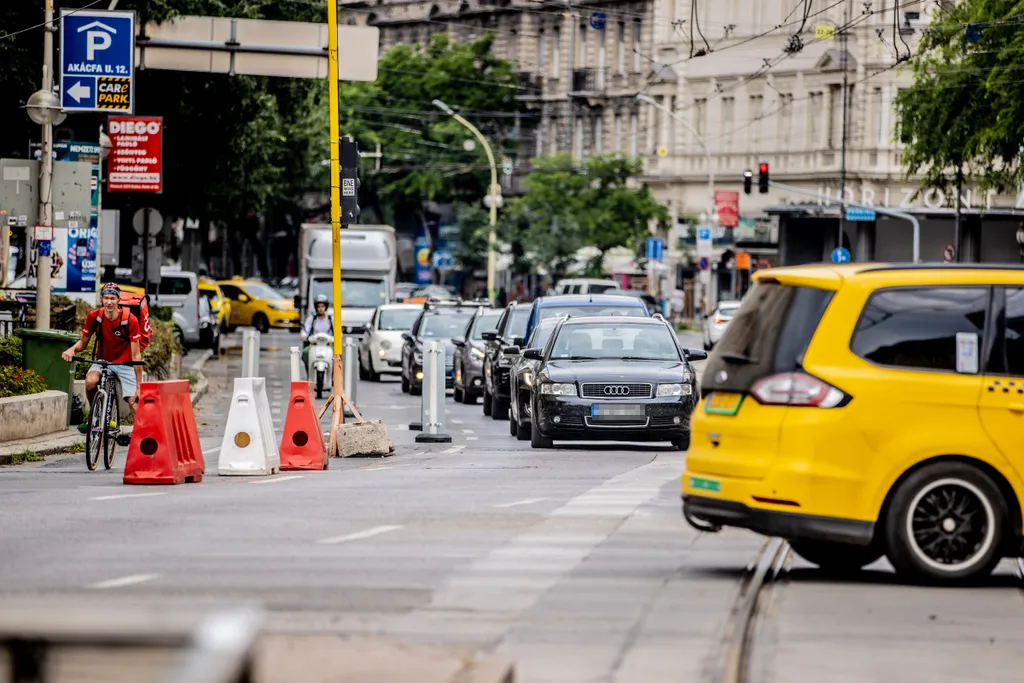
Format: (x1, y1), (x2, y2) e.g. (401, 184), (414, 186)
(106, 116), (164, 194)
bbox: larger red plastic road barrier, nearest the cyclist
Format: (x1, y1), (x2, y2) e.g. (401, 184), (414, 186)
(124, 380), (206, 483)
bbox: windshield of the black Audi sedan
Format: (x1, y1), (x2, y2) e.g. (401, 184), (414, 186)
(551, 324), (680, 360)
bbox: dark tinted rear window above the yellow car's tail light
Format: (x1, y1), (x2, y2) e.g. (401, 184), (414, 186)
(701, 283), (833, 392)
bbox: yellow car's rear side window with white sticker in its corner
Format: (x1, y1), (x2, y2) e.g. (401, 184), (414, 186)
(850, 287), (988, 375)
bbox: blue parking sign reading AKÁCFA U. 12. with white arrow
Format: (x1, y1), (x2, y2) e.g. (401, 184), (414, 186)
(60, 9), (135, 114)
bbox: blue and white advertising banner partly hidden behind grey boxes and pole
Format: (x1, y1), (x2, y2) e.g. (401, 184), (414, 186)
(29, 140), (99, 294)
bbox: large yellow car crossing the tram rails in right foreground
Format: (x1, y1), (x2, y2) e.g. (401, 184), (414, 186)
(682, 263), (1024, 583)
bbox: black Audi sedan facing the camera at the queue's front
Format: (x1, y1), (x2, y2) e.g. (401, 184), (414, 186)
(522, 316), (708, 451)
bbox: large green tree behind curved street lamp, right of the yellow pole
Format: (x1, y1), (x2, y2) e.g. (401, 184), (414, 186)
(340, 34), (518, 220)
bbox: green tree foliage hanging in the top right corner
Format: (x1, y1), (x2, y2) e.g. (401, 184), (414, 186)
(895, 0), (1024, 189)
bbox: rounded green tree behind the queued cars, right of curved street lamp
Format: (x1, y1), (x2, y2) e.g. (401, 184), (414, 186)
(502, 155), (668, 280)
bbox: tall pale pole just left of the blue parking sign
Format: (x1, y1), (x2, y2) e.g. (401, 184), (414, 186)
(36, 0), (56, 330)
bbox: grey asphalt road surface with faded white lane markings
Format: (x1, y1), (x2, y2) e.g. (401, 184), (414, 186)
(0, 333), (1024, 683)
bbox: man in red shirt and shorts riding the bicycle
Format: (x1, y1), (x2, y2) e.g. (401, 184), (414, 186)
(60, 283), (142, 431)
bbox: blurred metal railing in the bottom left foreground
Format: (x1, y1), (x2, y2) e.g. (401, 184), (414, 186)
(0, 608), (263, 683)
